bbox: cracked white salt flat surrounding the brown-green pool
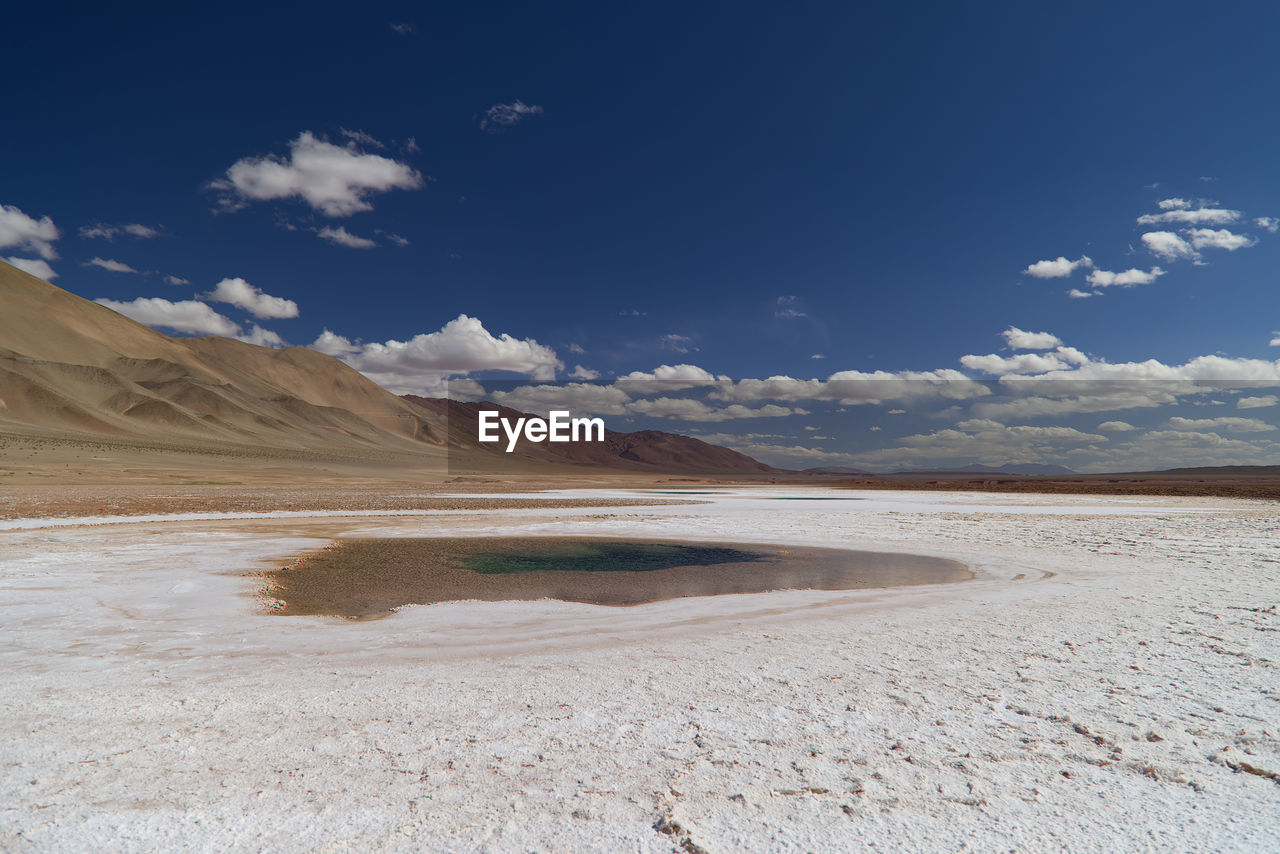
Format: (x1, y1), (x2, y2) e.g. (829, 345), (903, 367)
(0, 489), (1280, 851)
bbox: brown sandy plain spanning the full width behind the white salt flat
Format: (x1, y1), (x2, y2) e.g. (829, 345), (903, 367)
(0, 430), (1280, 519)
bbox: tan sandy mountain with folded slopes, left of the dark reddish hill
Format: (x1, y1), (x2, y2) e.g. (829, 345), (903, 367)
(0, 264), (443, 457)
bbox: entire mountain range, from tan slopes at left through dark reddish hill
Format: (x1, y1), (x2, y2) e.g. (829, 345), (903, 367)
(0, 264), (777, 475)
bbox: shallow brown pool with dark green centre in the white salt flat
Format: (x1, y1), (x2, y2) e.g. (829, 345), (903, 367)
(255, 536), (973, 620)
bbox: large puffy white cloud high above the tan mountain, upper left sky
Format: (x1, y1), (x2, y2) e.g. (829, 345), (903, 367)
(210, 131), (424, 216)
